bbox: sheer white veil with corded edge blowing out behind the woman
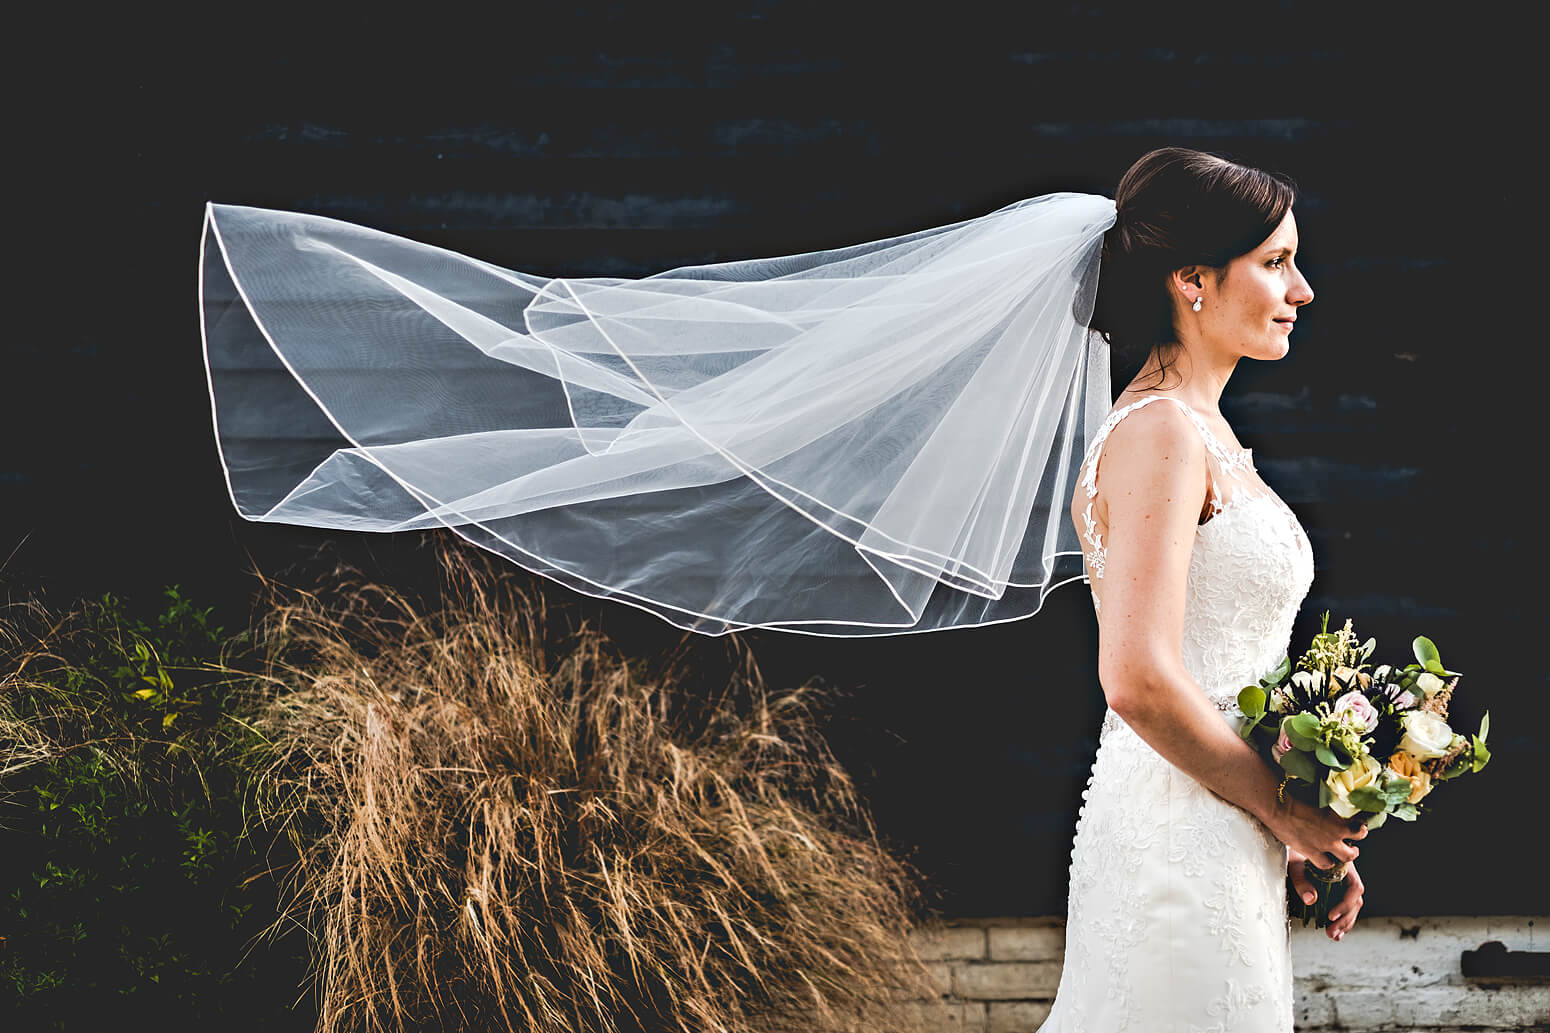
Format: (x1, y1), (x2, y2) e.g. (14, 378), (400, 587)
(200, 194), (1114, 636)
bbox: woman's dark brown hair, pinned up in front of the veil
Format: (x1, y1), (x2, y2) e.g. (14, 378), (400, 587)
(1091, 147), (1296, 388)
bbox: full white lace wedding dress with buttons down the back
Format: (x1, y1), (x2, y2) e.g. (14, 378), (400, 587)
(1042, 396), (1313, 1033)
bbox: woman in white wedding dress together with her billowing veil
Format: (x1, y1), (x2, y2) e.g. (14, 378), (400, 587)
(200, 147), (1366, 1033)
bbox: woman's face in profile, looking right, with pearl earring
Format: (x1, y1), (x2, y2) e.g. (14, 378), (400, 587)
(1181, 208), (1313, 358)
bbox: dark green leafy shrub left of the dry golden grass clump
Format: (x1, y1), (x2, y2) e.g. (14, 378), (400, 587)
(0, 588), (316, 1030)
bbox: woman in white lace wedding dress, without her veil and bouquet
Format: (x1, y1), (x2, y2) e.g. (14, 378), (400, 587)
(1043, 147), (1367, 1033)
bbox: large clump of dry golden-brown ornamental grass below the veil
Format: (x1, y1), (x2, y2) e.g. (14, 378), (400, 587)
(251, 549), (935, 1033)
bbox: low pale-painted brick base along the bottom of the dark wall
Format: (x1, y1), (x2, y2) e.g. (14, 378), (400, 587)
(915, 915), (1550, 1033)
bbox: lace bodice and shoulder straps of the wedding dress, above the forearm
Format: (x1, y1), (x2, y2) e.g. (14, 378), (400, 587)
(1080, 394), (1313, 704)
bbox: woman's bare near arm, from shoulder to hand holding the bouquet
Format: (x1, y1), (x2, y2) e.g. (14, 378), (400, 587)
(1097, 405), (1367, 867)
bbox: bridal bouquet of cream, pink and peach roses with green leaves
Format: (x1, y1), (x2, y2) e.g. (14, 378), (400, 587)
(1238, 613), (1491, 929)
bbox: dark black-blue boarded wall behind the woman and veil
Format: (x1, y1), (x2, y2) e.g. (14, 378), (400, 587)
(0, 0), (1550, 915)
